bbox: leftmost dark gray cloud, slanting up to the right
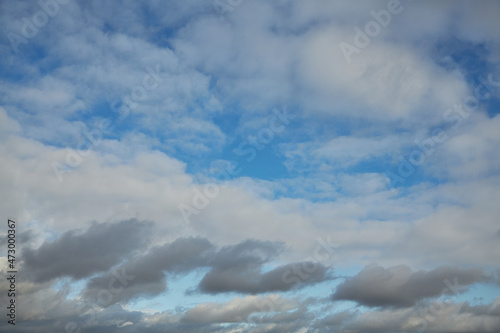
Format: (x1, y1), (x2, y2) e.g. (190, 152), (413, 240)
(23, 219), (152, 282)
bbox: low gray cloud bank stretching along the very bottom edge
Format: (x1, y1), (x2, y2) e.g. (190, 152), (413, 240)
(0, 295), (500, 333)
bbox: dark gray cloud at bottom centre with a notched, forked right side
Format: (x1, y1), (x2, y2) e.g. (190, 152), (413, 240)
(199, 240), (327, 294)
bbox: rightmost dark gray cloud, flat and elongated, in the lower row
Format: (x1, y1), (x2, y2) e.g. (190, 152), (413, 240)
(332, 265), (488, 307)
